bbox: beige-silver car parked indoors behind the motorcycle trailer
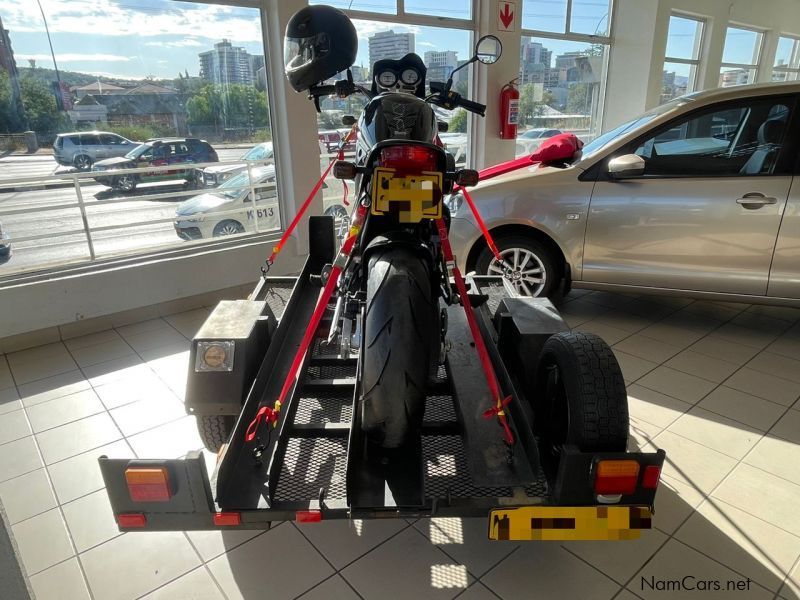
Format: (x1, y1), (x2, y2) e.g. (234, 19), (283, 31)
(448, 82), (800, 305)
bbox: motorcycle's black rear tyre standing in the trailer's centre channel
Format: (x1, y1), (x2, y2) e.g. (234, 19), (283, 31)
(361, 245), (438, 448)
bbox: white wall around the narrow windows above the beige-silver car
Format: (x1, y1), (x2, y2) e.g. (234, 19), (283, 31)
(603, 0), (800, 130)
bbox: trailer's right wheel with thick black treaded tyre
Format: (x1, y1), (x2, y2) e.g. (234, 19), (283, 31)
(533, 332), (628, 453)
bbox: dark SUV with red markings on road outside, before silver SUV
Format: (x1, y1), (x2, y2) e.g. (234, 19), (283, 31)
(92, 138), (219, 192)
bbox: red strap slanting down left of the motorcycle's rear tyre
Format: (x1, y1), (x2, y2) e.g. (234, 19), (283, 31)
(245, 204), (367, 442)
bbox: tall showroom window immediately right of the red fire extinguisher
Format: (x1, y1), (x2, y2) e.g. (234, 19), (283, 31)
(516, 0), (610, 156)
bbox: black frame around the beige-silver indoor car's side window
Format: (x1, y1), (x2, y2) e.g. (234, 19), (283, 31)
(597, 93), (800, 181)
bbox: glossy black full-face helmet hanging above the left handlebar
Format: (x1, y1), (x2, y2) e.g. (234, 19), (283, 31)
(283, 5), (358, 92)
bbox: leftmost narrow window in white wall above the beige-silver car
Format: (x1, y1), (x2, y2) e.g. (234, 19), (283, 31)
(661, 15), (705, 104)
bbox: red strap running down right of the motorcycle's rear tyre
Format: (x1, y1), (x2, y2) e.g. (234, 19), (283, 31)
(436, 219), (514, 446)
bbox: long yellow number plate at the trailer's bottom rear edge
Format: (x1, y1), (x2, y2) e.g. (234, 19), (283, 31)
(489, 506), (652, 540)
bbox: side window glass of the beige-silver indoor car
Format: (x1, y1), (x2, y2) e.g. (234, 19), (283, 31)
(625, 98), (791, 177)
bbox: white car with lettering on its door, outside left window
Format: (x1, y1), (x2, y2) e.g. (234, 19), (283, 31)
(175, 165), (280, 240)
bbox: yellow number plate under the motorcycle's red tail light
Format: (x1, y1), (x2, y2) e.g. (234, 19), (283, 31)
(370, 167), (442, 223)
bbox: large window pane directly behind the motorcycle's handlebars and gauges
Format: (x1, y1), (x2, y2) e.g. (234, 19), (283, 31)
(317, 19), (472, 219)
